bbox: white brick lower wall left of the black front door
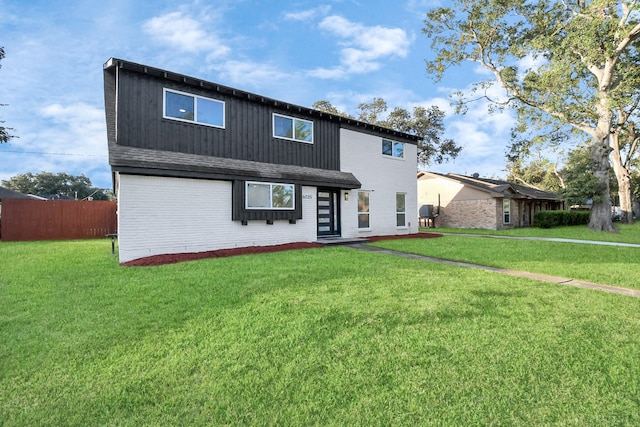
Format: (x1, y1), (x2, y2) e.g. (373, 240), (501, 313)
(118, 175), (316, 262)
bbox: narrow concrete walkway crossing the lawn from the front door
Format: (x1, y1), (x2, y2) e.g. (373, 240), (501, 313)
(346, 242), (640, 298)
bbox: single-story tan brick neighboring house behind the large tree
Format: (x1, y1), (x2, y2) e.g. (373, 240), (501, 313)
(418, 172), (563, 230)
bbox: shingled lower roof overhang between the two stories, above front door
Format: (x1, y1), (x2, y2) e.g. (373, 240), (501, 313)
(109, 144), (361, 189)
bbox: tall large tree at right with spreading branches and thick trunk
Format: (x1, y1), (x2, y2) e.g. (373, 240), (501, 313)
(424, 0), (640, 231)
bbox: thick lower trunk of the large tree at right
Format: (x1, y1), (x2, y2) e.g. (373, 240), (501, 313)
(589, 137), (616, 232)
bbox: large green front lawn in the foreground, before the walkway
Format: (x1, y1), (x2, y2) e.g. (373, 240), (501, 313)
(0, 238), (640, 426)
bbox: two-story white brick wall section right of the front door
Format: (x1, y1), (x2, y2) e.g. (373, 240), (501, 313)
(340, 129), (418, 237)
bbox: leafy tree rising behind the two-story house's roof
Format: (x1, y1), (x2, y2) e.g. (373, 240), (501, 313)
(313, 98), (462, 165)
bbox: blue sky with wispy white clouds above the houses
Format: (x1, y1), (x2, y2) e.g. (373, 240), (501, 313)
(0, 0), (513, 188)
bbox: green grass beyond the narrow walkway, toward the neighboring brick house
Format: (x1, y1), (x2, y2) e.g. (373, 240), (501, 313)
(404, 224), (640, 289)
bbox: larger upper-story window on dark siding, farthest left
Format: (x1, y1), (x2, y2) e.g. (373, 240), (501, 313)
(164, 89), (224, 128)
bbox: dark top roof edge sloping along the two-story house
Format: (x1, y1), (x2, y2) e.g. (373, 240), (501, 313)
(104, 58), (422, 144)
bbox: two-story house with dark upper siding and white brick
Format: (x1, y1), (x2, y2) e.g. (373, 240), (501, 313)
(104, 58), (418, 263)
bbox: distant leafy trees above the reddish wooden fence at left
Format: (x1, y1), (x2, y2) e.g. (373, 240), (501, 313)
(2, 172), (113, 200)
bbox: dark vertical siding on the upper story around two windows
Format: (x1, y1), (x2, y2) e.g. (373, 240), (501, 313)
(118, 69), (340, 170)
